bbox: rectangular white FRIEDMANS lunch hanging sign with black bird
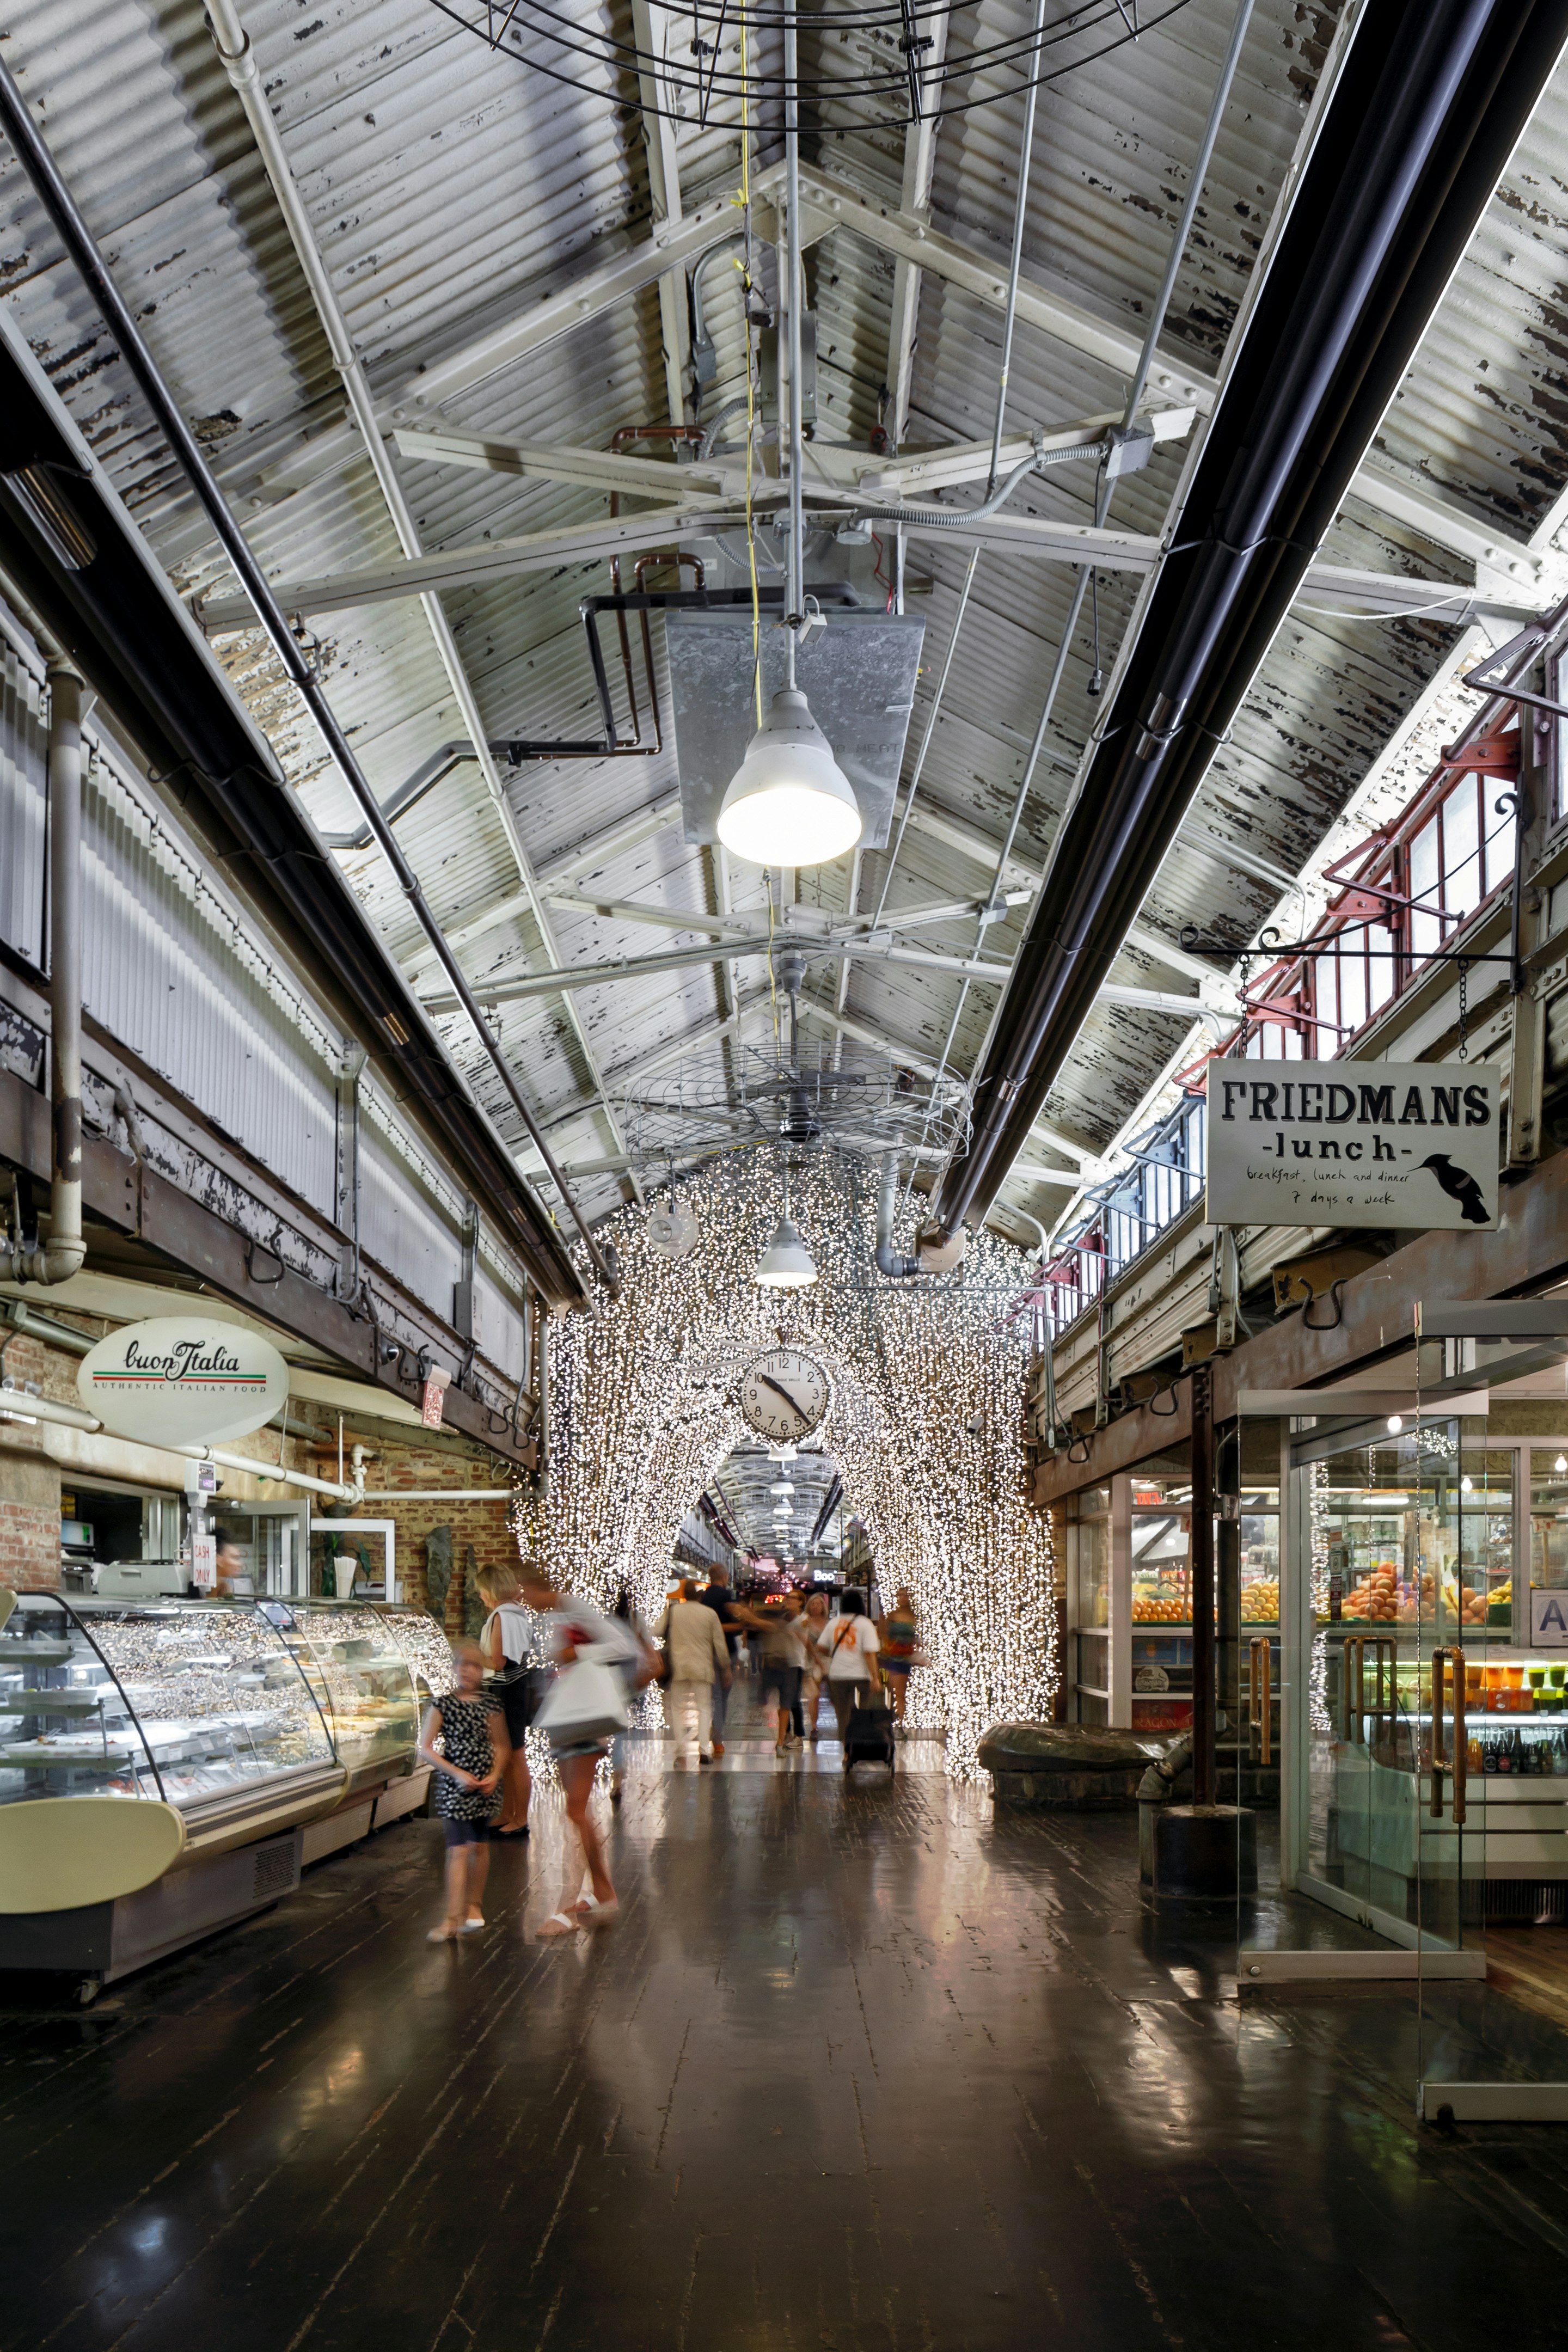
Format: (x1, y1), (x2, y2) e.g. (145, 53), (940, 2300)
(1208, 1061), (1500, 1233)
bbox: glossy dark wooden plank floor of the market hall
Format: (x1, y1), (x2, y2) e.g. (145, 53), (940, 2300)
(0, 1743), (1568, 2352)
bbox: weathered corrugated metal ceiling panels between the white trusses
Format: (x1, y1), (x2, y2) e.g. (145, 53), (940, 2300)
(0, 0), (1568, 1251)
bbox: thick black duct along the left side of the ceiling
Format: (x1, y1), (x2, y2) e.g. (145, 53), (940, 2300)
(0, 336), (583, 1306)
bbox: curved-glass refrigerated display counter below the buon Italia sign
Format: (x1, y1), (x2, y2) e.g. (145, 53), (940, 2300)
(0, 1592), (449, 1990)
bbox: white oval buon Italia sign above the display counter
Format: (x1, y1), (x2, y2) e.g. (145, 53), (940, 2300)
(75, 1315), (289, 1447)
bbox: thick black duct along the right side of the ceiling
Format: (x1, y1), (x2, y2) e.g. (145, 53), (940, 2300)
(933, 0), (1568, 1240)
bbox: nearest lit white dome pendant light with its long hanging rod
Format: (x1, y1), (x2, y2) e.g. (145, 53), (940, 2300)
(717, 7), (860, 866)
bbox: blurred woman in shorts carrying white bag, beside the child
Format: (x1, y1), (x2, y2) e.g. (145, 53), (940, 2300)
(519, 1559), (637, 1943)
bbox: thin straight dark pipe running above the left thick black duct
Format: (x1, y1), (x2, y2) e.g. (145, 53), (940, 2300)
(0, 61), (618, 1296)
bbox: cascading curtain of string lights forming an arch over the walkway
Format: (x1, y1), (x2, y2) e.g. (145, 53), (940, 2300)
(515, 1148), (1058, 1778)
